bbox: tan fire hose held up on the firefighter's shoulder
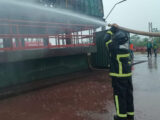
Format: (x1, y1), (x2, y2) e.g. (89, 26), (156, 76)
(108, 24), (160, 37)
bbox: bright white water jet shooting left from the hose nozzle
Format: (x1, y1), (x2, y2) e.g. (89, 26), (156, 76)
(0, 0), (106, 26)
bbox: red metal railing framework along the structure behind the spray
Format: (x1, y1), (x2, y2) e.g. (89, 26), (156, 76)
(0, 19), (95, 51)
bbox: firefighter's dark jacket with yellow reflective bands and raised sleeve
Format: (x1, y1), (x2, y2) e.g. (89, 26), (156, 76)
(105, 30), (132, 77)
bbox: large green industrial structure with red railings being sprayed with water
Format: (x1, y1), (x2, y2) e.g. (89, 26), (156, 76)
(0, 0), (104, 95)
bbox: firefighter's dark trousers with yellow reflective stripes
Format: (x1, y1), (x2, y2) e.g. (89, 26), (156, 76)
(112, 77), (134, 120)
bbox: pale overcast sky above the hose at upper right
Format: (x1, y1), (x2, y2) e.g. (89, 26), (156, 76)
(103, 0), (160, 31)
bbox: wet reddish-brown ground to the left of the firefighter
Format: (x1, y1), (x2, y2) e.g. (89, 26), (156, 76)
(0, 71), (114, 120)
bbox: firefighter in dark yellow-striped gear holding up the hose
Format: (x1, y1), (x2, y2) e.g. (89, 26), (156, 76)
(104, 25), (134, 120)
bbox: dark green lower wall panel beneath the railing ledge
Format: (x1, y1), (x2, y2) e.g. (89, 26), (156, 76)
(0, 55), (88, 88)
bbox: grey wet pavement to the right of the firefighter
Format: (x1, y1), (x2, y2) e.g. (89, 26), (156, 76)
(133, 54), (160, 120)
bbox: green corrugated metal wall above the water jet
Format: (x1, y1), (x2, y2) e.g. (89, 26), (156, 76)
(39, 0), (104, 18)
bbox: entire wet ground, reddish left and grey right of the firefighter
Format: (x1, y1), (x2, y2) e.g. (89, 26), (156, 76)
(0, 54), (160, 120)
